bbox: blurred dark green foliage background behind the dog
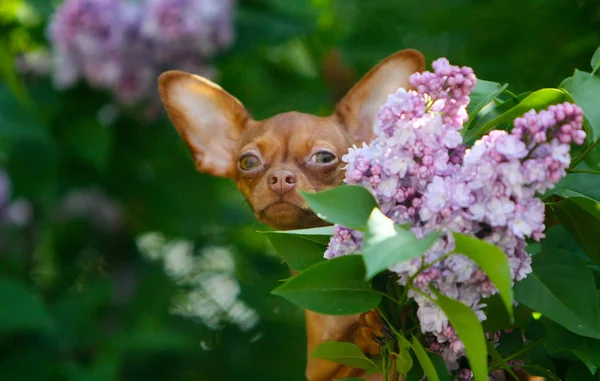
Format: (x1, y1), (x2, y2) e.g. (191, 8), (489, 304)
(0, 0), (600, 381)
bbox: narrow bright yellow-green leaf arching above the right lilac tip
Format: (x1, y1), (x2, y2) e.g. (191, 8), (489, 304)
(465, 89), (565, 141)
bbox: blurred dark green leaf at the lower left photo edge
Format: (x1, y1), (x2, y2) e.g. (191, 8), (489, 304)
(0, 278), (53, 333)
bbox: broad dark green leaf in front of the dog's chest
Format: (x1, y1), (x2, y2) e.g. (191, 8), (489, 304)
(273, 255), (381, 315)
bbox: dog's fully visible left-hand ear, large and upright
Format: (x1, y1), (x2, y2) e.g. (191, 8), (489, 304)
(158, 70), (250, 178)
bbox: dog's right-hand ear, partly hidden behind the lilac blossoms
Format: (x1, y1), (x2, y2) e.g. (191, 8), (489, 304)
(335, 49), (425, 144)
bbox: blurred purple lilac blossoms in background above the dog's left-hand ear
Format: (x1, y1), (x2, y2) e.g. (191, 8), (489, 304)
(48, 0), (235, 105)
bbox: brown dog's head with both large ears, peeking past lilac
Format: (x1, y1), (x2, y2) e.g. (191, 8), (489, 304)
(159, 50), (424, 229)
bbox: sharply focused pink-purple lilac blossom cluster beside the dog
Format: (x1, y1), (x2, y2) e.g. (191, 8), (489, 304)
(325, 58), (585, 375)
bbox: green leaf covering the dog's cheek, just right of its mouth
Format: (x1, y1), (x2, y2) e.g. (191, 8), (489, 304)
(300, 185), (377, 230)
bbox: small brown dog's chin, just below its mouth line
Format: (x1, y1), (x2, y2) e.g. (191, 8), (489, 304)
(257, 201), (327, 230)
